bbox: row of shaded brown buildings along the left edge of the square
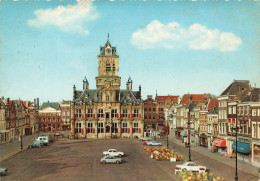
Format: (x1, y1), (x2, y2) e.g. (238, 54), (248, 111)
(0, 97), (39, 143)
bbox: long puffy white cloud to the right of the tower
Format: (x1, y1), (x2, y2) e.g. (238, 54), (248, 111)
(131, 20), (242, 52)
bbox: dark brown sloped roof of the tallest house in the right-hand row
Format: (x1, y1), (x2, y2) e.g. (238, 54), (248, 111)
(221, 80), (251, 96)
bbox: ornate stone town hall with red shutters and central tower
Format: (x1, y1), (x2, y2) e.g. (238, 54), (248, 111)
(71, 36), (144, 138)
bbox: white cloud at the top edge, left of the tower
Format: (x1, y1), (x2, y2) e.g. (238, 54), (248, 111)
(28, 1), (98, 35)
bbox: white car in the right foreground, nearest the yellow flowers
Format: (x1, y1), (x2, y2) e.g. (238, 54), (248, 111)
(175, 162), (207, 174)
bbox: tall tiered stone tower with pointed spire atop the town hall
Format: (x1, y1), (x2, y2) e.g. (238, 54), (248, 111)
(96, 35), (121, 102)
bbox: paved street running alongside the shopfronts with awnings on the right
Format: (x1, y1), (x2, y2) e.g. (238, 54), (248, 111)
(161, 137), (259, 181)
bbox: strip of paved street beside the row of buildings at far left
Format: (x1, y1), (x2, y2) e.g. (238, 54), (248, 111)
(0, 134), (37, 162)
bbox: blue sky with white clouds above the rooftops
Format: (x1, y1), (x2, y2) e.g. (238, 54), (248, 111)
(0, 0), (260, 103)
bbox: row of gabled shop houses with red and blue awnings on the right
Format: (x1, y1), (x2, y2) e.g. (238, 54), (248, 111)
(165, 80), (260, 166)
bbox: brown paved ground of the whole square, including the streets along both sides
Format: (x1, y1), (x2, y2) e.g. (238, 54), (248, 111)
(0, 135), (258, 181)
